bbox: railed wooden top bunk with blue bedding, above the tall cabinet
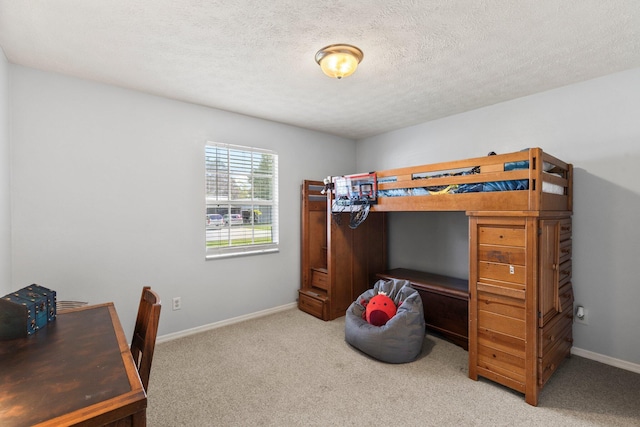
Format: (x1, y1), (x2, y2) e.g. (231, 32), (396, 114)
(356, 148), (573, 212)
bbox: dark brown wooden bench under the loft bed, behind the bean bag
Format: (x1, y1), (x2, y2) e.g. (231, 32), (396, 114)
(376, 268), (469, 350)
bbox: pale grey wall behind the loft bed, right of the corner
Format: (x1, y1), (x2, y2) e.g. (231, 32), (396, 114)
(355, 69), (640, 364)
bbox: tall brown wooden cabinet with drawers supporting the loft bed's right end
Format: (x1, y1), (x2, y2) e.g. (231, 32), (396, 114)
(469, 212), (573, 405)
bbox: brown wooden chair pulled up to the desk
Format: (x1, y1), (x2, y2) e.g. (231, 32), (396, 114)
(131, 286), (161, 391)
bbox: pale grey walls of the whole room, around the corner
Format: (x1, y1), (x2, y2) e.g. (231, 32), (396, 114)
(7, 56), (640, 364)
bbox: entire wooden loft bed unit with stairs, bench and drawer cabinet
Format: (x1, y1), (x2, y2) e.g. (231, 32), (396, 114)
(308, 148), (573, 406)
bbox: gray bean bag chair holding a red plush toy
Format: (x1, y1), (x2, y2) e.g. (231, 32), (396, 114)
(345, 279), (425, 363)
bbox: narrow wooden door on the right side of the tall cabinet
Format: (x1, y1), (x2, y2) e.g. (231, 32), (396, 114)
(538, 219), (561, 327)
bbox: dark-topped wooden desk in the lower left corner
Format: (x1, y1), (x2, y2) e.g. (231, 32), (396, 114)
(0, 303), (147, 427)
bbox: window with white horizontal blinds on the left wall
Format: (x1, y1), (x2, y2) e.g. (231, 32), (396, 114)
(205, 142), (278, 258)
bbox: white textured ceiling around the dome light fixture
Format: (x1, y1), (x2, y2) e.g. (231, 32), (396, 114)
(0, 0), (640, 139)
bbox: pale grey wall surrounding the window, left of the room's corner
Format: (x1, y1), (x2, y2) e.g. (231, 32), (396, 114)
(8, 65), (355, 342)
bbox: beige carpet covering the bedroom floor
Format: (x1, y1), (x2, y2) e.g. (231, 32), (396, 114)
(147, 309), (640, 427)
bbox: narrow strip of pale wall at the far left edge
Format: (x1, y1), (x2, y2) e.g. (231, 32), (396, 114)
(0, 48), (12, 296)
